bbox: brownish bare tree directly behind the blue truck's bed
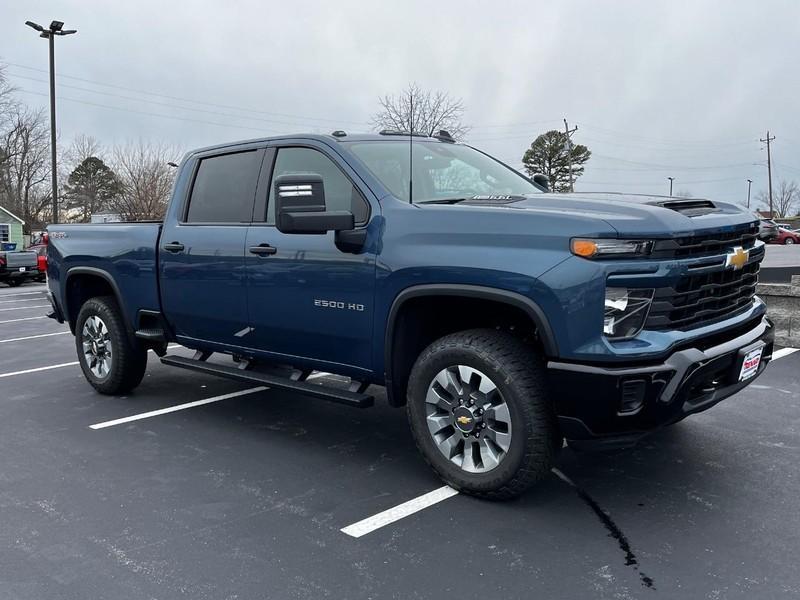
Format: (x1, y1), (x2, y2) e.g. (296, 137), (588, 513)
(110, 141), (179, 221)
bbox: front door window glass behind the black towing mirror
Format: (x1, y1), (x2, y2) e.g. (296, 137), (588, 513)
(267, 148), (369, 225)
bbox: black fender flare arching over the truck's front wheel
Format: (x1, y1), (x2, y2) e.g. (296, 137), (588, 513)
(384, 283), (558, 406)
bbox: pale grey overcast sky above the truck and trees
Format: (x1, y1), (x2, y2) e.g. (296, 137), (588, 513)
(0, 0), (800, 209)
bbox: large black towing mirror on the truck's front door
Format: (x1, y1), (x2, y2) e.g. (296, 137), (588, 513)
(275, 173), (355, 234)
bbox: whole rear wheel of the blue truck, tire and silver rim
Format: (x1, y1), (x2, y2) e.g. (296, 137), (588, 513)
(75, 296), (147, 395)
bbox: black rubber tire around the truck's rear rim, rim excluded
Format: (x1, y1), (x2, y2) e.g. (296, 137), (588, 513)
(75, 296), (147, 395)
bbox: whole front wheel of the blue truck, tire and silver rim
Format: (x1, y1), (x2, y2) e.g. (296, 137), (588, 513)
(407, 329), (561, 499)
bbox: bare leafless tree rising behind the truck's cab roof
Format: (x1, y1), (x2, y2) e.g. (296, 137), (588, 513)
(372, 83), (469, 139)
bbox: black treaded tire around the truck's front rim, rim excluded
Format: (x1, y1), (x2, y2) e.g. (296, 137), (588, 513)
(407, 329), (562, 500)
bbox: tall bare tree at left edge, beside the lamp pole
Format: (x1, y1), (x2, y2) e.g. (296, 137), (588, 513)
(0, 104), (50, 228)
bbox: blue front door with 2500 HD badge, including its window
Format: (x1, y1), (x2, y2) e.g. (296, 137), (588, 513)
(244, 142), (380, 374)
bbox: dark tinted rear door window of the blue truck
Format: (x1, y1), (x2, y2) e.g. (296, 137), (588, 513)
(186, 150), (261, 223)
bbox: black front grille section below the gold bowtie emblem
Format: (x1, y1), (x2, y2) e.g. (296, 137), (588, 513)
(645, 258), (764, 330)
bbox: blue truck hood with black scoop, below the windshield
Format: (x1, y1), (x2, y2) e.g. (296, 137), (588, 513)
(457, 193), (758, 238)
